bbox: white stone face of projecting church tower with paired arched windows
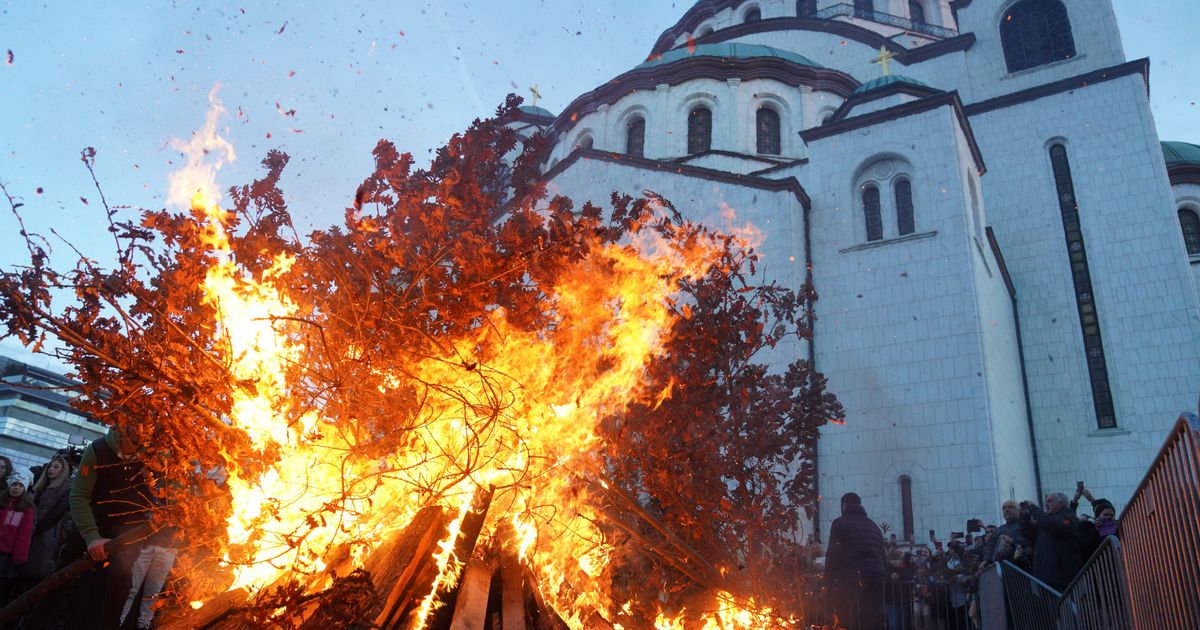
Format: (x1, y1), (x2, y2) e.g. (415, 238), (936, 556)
(805, 108), (998, 541)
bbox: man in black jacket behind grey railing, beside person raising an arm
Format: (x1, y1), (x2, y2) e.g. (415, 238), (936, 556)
(1021, 492), (1081, 592)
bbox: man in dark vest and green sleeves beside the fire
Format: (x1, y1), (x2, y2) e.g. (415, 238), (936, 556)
(68, 427), (151, 630)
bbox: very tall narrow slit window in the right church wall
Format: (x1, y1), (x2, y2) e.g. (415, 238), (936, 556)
(1050, 144), (1117, 428)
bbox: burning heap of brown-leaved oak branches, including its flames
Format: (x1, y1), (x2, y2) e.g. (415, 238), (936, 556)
(0, 90), (841, 628)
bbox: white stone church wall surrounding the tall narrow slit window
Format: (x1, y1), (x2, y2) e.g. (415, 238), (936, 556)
(971, 74), (1200, 509)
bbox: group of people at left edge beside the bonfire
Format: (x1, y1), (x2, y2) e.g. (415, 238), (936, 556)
(0, 430), (176, 629)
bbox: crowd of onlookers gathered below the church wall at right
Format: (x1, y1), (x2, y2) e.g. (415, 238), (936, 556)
(823, 482), (1117, 630)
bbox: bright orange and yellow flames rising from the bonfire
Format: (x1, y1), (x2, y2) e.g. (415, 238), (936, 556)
(170, 89), (769, 628)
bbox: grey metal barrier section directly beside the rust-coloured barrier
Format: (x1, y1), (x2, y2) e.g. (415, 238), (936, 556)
(1057, 536), (1133, 630)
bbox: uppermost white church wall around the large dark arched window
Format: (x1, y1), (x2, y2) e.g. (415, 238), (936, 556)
(955, 0), (1126, 103)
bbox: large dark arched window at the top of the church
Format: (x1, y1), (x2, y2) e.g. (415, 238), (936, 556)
(1000, 0), (1075, 72)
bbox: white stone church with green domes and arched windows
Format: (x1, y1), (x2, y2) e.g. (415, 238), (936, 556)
(504, 0), (1200, 542)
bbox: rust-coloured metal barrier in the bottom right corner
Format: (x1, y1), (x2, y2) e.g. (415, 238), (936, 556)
(1118, 414), (1200, 630)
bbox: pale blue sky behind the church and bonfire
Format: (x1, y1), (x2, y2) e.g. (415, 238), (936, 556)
(0, 0), (1200, 367)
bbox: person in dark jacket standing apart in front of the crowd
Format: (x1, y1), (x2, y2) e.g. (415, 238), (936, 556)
(826, 492), (888, 630)
